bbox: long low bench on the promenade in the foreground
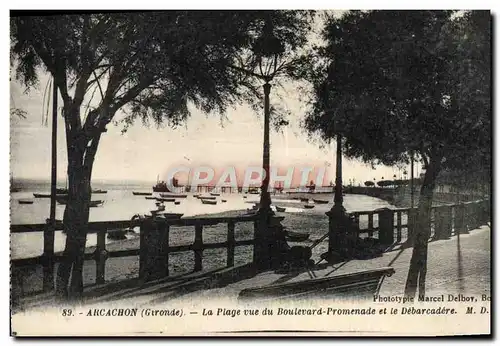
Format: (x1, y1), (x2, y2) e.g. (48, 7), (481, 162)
(238, 267), (395, 301)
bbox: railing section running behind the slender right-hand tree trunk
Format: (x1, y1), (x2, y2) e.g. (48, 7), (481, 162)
(349, 200), (491, 244)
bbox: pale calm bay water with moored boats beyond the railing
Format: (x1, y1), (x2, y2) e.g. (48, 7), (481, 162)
(10, 182), (391, 259)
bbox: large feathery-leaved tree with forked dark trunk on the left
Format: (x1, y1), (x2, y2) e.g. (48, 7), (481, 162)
(11, 11), (310, 298)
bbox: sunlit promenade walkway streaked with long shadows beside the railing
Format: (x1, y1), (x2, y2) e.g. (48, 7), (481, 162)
(13, 226), (491, 310)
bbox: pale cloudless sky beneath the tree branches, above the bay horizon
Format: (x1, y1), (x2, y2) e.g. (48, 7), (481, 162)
(10, 12), (420, 185)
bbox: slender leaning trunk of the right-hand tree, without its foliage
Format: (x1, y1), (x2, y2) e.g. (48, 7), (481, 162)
(405, 153), (442, 298)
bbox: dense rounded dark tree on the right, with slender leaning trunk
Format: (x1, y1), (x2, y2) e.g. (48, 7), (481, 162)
(306, 11), (491, 296)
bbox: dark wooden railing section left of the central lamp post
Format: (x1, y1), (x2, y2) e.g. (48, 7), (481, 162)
(10, 215), (257, 293)
